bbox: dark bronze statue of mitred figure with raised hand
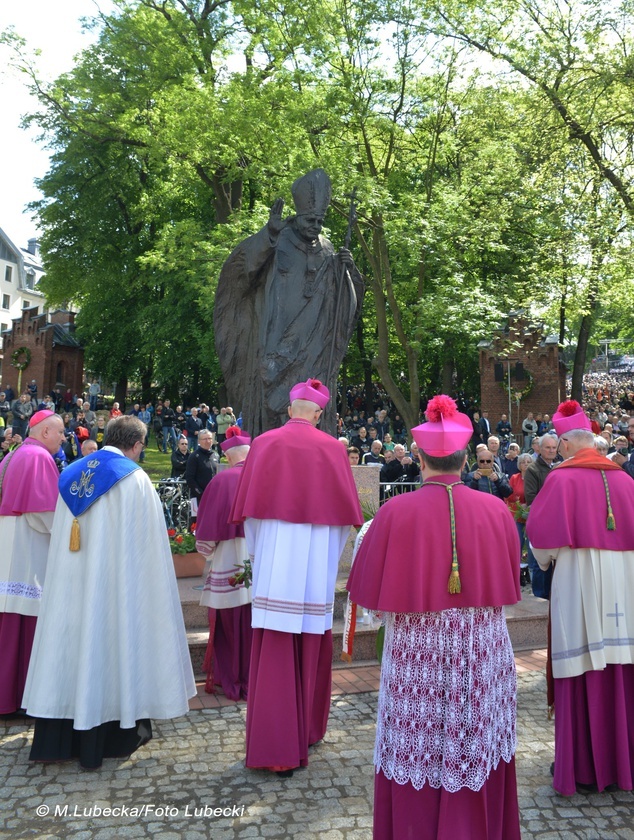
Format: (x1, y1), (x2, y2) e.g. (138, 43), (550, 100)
(214, 169), (364, 436)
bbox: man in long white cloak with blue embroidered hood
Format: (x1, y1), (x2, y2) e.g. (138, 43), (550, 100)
(24, 416), (196, 769)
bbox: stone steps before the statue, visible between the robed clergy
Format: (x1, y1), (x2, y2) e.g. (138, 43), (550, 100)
(178, 578), (548, 675)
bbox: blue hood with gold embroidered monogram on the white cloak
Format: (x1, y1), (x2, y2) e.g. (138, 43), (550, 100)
(59, 449), (141, 518)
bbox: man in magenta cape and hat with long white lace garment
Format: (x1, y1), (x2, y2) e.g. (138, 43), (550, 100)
(348, 396), (520, 840)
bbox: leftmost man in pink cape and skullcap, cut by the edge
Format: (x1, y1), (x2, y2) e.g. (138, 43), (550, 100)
(0, 410), (64, 714)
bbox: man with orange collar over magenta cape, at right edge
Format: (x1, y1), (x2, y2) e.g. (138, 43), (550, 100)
(527, 400), (634, 796)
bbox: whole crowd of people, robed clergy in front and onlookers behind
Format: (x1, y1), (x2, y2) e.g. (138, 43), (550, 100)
(0, 370), (634, 840)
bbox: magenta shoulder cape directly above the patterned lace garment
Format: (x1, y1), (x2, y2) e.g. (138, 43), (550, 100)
(347, 475), (520, 613)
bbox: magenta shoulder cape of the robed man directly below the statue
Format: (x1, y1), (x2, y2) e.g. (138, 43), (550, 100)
(231, 420), (360, 524)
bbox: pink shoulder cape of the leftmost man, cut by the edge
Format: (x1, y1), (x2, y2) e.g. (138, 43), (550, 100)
(0, 438), (59, 516)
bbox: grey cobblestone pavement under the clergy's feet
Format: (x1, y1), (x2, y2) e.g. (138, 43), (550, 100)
(0, 650), (634, 840)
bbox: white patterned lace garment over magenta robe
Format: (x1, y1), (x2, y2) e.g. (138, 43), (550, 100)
(374, 607), (517, 793)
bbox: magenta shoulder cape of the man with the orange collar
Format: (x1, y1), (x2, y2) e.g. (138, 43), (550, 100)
(526, 462), (634, 551)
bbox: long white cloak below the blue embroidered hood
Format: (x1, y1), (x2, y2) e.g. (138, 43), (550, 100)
(23, 447), (196, 730)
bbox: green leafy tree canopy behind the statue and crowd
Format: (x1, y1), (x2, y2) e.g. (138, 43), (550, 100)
(6, 0), (634, 414)
